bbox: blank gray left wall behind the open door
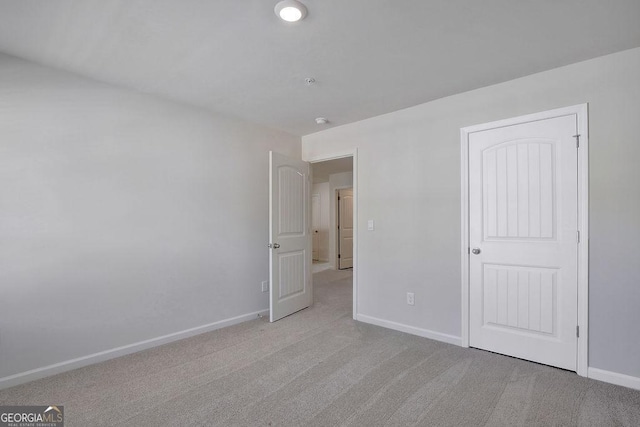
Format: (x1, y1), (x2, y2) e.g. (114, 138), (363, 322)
(0, 55), (300, 378)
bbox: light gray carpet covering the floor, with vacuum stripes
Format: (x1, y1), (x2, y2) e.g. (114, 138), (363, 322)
(0, 270), (640, 426)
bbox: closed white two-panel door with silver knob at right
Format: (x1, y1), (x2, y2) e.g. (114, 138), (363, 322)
(469, 115), (578, 371)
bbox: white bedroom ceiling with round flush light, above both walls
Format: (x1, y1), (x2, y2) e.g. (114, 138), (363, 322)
(0, 0), (640, 135)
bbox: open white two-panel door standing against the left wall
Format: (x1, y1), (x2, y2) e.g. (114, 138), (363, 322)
(269, 151), (313, 322)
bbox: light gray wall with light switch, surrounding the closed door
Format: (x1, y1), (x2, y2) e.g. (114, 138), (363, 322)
(303, 49), (640, 377)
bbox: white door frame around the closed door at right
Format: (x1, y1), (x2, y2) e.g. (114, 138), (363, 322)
(460, 104), (589, 377)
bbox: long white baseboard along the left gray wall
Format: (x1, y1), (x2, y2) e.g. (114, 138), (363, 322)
(0, 310), (269, 390)
